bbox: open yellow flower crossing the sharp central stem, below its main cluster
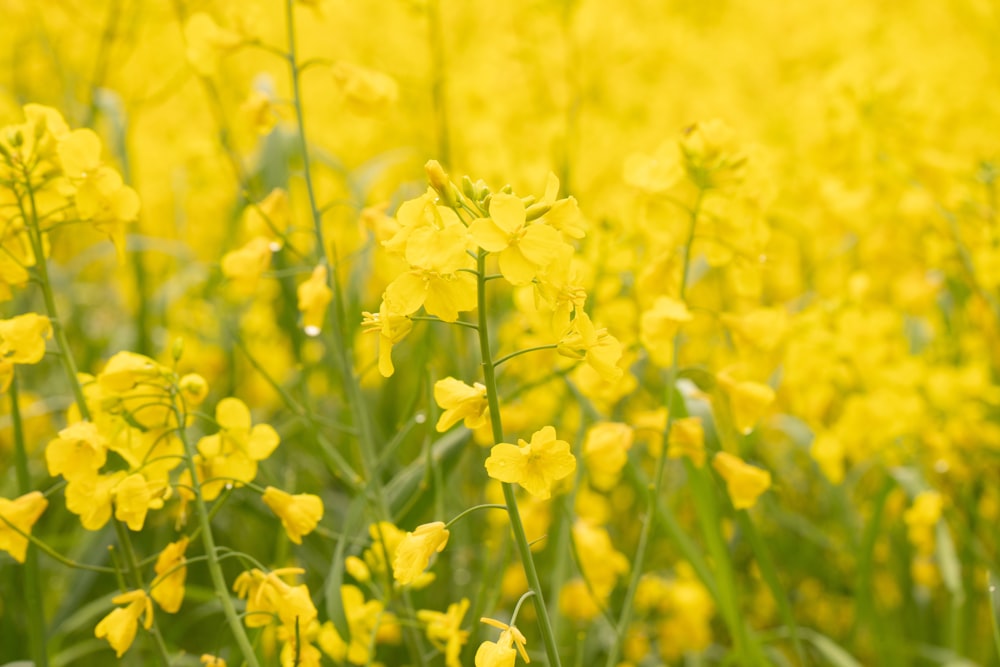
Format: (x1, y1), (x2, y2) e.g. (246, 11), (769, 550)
(486, 426), (576, 500)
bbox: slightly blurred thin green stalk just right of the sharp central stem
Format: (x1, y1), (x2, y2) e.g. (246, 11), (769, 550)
(605, 189), (705, 667)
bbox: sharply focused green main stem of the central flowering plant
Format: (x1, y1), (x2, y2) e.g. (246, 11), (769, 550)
(476, 251), (562, 667)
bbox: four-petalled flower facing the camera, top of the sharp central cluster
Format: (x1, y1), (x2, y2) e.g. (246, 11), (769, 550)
(469, 192), (565, 285)
